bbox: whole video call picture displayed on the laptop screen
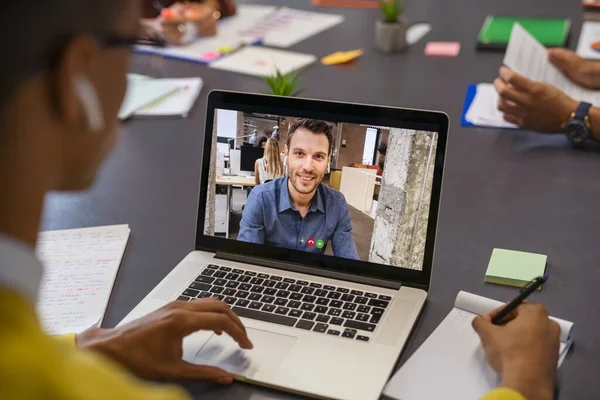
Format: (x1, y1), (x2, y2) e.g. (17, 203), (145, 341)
(205, 110), (438, 270)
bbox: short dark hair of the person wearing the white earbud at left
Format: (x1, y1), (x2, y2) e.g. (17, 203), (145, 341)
(0, 0), (125, 108)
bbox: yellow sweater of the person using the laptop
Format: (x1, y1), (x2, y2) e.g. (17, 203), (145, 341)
(0, 291), (525, 400)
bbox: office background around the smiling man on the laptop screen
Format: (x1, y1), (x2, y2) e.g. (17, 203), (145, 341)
(205, 110), (437, 269)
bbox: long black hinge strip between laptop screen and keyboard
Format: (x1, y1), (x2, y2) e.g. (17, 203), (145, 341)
(215, 251), (402, 290)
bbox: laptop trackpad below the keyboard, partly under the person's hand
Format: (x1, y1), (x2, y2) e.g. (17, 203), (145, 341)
(195, 328), (296, 378)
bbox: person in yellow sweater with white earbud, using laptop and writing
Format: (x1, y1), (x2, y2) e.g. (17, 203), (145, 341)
(0, 0), (558, 400)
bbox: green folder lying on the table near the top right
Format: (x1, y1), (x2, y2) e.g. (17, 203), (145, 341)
(477, 15), (571, 50)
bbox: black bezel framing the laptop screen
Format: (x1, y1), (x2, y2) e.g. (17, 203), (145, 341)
(196, 90), (449, 290)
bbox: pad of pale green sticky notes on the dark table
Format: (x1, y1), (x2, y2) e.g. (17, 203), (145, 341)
(485, 249), (548, 287)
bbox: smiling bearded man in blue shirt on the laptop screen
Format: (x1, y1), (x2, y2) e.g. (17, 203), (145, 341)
(238, 119), (358, 260)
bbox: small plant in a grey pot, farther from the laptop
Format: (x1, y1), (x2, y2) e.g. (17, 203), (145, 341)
(375, 0), (408, 53)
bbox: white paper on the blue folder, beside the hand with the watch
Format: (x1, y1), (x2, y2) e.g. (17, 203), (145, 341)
(465, 83), (519, 129)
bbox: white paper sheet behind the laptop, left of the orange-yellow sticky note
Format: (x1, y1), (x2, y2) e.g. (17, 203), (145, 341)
(210, 46), (316, 76)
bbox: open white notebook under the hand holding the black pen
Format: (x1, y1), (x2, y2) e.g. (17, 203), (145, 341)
(384, 291), (573, 400)
